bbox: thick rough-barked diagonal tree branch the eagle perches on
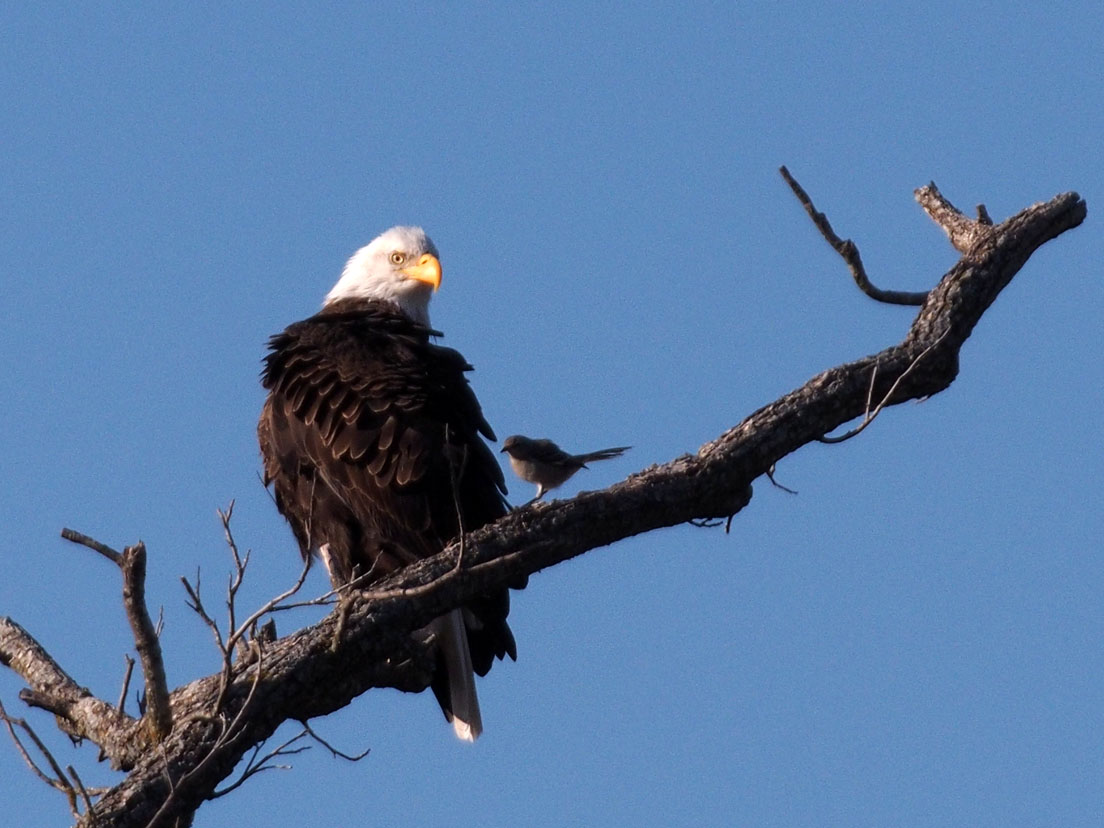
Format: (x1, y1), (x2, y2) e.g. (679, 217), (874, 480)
(0, 185), (1086, 828)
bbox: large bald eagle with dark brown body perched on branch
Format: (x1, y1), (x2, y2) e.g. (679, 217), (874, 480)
(257, 227), (523, 741)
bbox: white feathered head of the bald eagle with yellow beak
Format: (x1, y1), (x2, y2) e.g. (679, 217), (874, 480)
(325, 227), (440, 327)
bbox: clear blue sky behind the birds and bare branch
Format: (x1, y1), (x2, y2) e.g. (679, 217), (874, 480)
(0, 2), (1104, 828)
